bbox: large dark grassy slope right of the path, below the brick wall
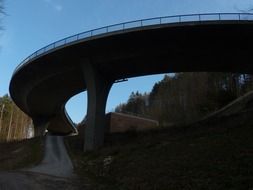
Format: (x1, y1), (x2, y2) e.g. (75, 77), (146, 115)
(65, 111), (253, 190)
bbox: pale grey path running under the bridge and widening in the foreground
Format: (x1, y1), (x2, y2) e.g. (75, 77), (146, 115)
(0, 135), (87, 190)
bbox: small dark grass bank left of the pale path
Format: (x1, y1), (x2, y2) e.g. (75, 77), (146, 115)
(0, 138), (44, 171)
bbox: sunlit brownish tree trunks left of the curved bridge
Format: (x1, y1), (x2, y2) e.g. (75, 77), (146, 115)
(0, 95), (33, 141)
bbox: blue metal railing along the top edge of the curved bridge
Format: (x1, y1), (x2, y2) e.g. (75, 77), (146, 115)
(14, 13), (253, 73)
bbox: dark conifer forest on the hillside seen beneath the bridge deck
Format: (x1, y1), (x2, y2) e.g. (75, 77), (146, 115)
(115, 72), (253, 126)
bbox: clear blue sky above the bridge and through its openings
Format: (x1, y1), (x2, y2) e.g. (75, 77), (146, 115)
(0, 0), (253, 121)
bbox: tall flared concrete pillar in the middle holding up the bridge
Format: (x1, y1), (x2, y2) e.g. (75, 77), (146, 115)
(82, 61), (113, 151)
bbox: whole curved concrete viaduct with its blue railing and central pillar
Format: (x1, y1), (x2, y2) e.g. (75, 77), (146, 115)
(10, 14), (253, 150)
